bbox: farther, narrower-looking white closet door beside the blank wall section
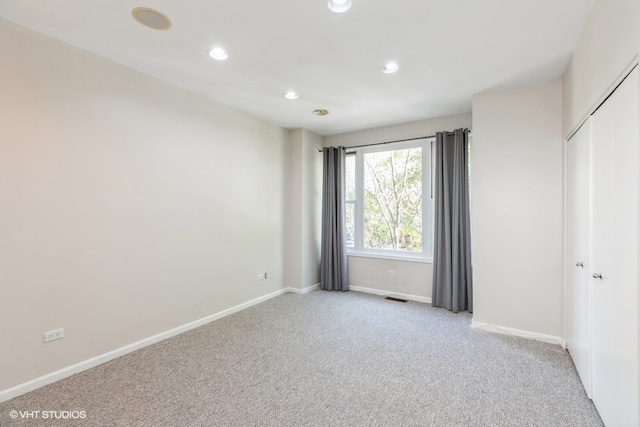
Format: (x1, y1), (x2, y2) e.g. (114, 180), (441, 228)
(566, 120), (591, 397)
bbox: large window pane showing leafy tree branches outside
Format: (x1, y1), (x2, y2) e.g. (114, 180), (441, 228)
(364, 148), (422, 252)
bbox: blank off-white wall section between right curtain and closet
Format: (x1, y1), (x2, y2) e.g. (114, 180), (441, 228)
(472, 80), (564, 340)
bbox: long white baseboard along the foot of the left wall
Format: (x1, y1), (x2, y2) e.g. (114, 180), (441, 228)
(0, 288), (288, 403)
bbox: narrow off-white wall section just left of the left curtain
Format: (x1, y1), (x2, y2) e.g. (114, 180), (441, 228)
(284, 129), (322, 290)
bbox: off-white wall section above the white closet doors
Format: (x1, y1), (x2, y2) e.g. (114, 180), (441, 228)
(563, 0), (640, 138)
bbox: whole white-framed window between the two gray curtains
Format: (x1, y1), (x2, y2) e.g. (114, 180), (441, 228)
(345, 139), (433, 259)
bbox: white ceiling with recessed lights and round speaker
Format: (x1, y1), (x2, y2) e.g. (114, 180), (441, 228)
(0, 0), (594, 135)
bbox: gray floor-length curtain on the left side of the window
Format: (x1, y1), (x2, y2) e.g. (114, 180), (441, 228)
(320, 147), (349, 291)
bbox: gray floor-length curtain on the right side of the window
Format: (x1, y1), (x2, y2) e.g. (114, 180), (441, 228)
(431, 129), (473, 313)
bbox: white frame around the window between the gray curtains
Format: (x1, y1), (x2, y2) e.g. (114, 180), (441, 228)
(345, 137), (435, 262)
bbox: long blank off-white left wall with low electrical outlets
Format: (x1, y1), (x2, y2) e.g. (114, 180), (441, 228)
(0, 21), (287, 390)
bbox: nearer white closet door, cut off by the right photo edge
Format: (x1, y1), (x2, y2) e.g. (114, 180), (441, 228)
(590, 70), (640, 427)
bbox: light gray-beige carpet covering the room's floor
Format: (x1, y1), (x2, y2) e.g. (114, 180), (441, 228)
(0, 291), (602, 427)
